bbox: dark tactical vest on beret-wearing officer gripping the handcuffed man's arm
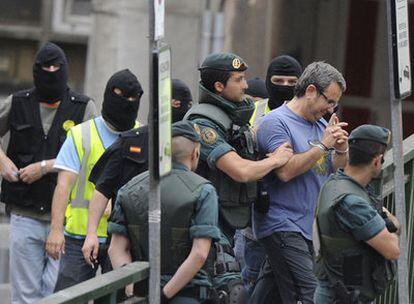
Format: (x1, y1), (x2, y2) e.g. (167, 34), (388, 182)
(184, 103), (257, 229)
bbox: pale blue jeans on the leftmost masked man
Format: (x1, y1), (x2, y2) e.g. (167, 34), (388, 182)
(10, 213), (59, 304)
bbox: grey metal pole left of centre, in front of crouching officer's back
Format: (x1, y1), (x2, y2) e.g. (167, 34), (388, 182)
(148, 0), (161, 304)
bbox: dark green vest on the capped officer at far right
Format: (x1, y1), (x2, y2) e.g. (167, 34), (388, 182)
(316, 174), (394, 301)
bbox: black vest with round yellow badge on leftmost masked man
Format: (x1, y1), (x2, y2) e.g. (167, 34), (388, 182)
(1, 90), (90, 213)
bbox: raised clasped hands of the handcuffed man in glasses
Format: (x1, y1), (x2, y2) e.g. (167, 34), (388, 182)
(321, 113), (348, 151)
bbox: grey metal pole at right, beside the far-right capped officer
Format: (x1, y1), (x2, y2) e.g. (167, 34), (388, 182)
(386, 0), (410, 304)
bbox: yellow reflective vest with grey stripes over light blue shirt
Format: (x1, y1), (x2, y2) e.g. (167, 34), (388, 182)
(65, 119), (138, 237)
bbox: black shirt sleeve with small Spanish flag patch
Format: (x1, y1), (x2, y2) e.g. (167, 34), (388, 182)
(89, 126), (148, 201)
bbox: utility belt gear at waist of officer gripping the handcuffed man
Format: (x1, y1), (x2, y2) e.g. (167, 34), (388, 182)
(203, 243), (241, 277)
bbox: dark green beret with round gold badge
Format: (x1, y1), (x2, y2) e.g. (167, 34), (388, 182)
(199, 53), (247, 72)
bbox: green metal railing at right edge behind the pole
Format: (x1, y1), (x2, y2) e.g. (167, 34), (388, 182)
(375, 134), (414, 304)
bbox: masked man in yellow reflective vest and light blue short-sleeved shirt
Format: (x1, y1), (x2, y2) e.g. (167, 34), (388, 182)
(46, 69), (142, 291)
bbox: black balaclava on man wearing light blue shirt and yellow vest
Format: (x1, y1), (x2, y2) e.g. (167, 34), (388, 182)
(102, 69), (143, 132)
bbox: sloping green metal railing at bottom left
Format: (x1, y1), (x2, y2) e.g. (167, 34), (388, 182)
(38, 262), (149, 304)
